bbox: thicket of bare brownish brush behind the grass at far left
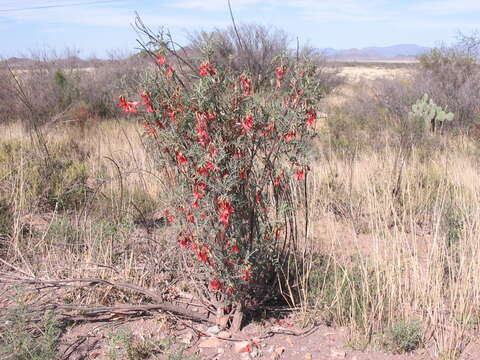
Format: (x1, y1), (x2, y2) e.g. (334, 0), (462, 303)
(0, 50), (147, 128)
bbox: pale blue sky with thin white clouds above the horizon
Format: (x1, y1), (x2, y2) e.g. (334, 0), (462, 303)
(0, 0), (480, 57)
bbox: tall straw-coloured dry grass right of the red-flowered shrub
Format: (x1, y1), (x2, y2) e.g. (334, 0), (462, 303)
(300, 139), (480, 359)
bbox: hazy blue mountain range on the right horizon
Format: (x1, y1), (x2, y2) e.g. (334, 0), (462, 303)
(322, 44), (430, 60)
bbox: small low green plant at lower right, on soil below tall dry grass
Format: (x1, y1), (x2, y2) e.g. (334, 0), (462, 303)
(386, 320), (422, 353)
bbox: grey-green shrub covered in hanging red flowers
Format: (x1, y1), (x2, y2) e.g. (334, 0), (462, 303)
(119, 36), (322, 326)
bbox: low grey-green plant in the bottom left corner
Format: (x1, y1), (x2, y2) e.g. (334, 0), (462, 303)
(0, 306), (61, 360)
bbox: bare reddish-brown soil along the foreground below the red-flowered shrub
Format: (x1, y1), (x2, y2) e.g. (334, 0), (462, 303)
(54, 315), (440, 360)
